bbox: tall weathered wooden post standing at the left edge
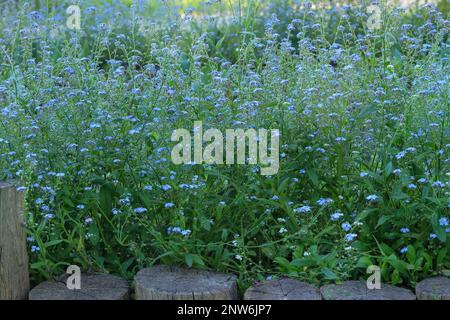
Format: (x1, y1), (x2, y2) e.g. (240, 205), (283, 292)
(0, 182), (30, 300)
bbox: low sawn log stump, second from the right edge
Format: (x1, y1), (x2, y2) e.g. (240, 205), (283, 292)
(320, 281), (416, 300)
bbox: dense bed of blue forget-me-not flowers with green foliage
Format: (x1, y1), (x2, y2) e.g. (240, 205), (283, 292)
(0, 1), (450, 288)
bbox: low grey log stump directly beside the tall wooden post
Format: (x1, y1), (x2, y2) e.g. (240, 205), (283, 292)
(30, 274), (129, 300)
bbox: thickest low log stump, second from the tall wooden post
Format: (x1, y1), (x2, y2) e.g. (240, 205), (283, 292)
(134, 265), (238, 300)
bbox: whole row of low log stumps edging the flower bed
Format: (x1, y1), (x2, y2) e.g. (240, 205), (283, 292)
(29, 272), (450, 300)
